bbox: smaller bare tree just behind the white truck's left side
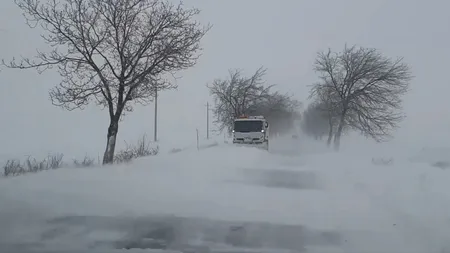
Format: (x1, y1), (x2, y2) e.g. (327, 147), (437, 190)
(207, 67), (272, 131)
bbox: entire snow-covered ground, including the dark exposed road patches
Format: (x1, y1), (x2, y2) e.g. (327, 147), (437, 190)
(0, 136), (450, 253)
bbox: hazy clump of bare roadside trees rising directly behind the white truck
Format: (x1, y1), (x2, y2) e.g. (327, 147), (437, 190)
(208, 67), (301, 134)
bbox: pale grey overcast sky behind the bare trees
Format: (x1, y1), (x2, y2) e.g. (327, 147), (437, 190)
(0, 0), (450, 156)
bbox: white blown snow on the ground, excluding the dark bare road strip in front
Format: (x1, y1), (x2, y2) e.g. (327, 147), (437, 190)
(0, 137), (450, 253)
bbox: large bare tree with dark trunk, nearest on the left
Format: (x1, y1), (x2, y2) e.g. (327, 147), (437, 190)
(3, 0), (210, 164)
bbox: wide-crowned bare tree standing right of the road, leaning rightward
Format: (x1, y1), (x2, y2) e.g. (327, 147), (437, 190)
(311, 46), (412, 149)
